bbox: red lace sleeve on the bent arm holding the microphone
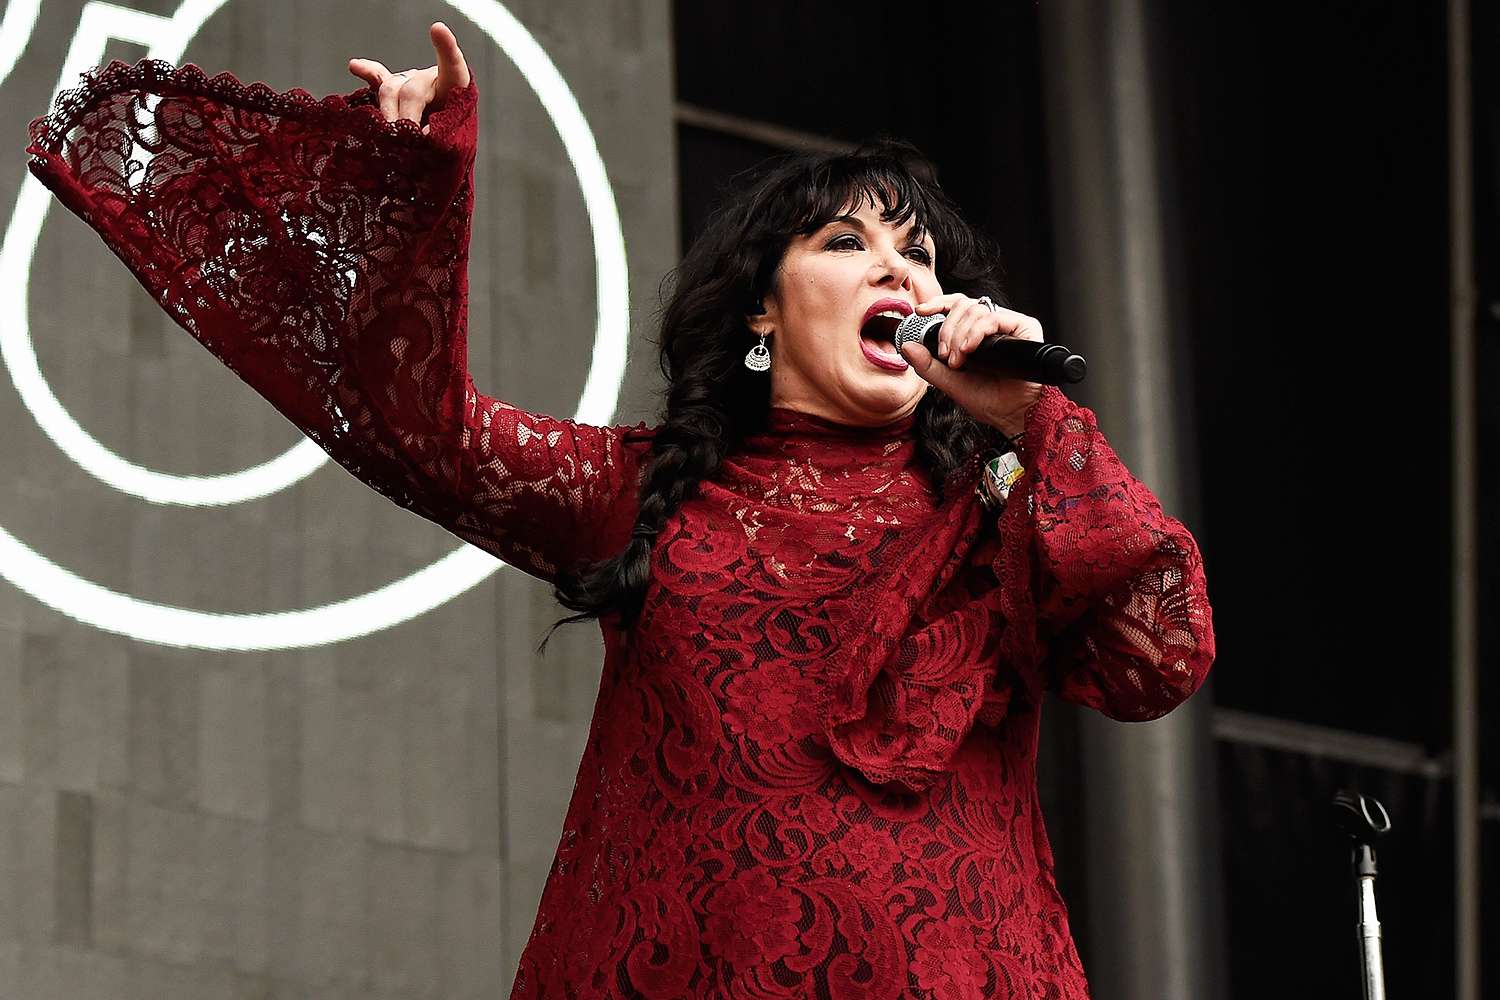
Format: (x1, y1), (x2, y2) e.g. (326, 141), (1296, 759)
(1013, 388), (1214, 721)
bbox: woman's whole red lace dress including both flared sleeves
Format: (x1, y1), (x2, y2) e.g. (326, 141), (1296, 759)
(30, 63), (1214, 1000)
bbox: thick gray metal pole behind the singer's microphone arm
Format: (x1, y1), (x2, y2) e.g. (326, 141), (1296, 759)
(1041, 0), (1224, 1000)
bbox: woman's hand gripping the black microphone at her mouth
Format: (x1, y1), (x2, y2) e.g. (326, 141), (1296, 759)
(896, 292), (1088, 436)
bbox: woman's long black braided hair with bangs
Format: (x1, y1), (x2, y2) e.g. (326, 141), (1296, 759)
(539, 138), (1007, 651)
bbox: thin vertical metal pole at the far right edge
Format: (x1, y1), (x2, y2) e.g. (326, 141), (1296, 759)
(1448, 0), (1481, 1000)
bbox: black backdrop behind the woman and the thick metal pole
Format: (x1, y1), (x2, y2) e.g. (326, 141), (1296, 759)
(675, 0), (1500, 997)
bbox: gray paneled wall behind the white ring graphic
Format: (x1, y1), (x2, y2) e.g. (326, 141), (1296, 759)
(0, 0), (677, 1000)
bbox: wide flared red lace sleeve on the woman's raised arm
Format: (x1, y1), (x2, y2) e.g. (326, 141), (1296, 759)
(27, 60), (650, 580)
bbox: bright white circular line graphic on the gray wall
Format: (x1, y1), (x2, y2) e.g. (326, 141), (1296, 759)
(0, 0), (629, 649)
